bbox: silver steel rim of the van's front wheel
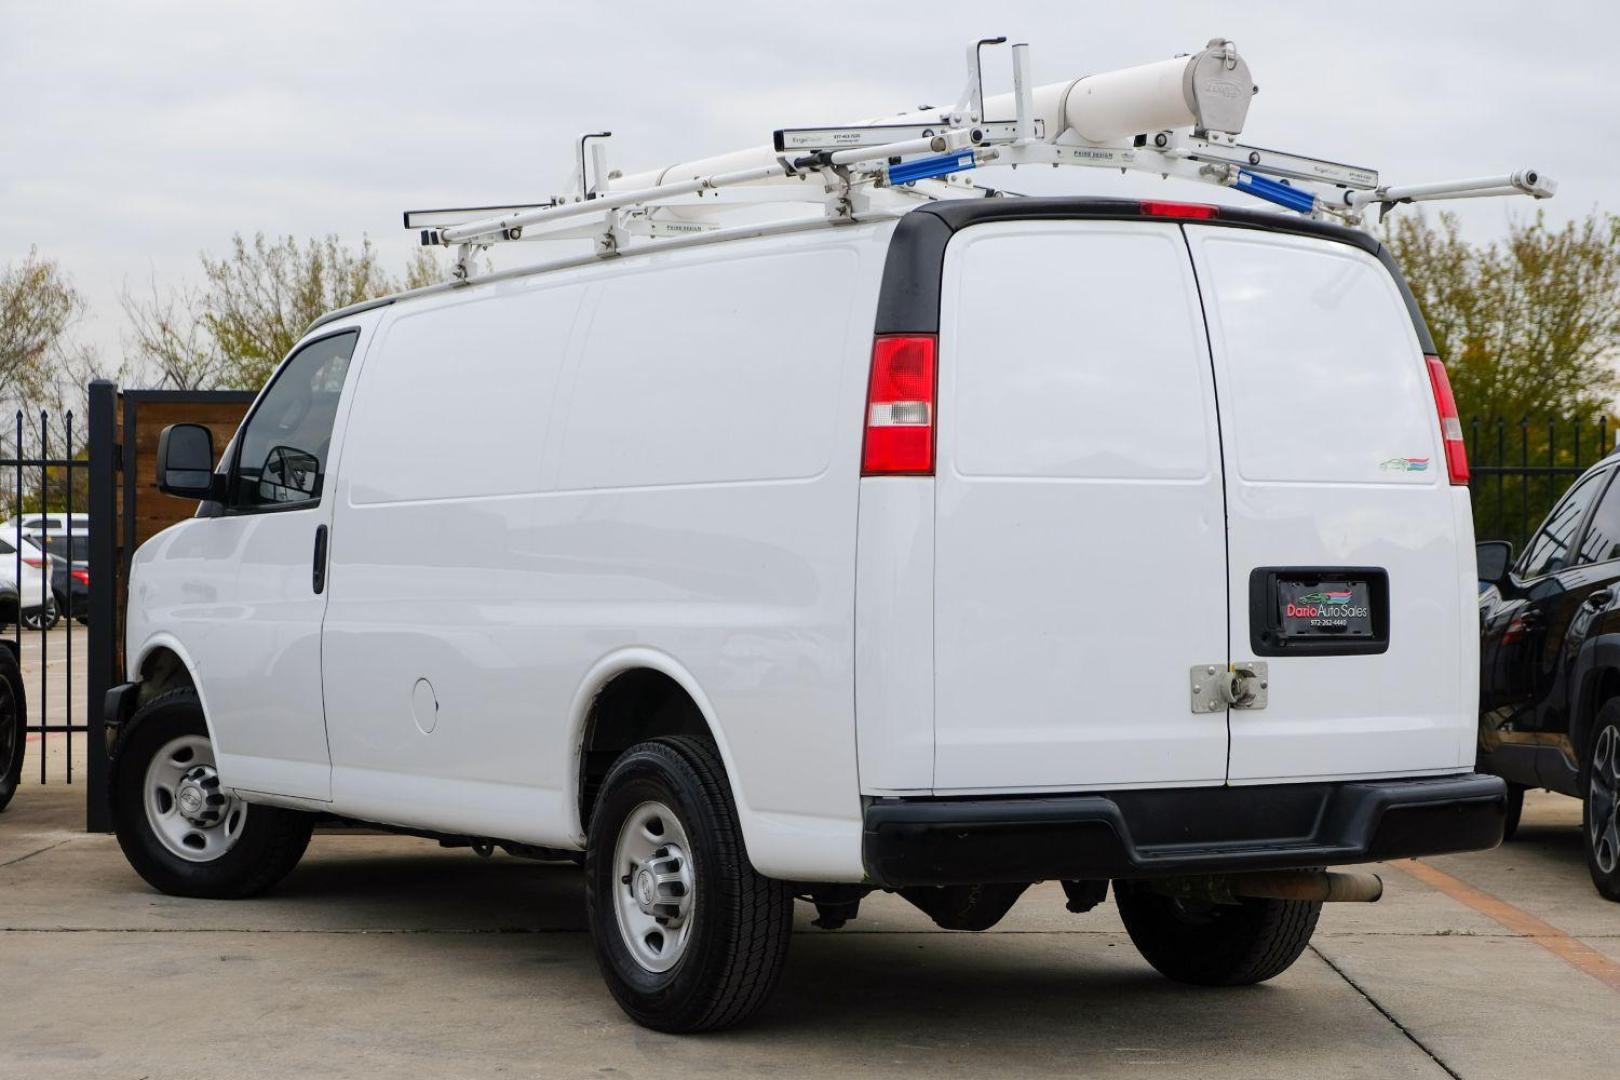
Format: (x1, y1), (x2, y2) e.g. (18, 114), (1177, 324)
(143, 735), (248, 863)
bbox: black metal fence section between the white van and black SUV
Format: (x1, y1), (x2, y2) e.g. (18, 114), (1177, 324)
(1463, 416), (1620, 549)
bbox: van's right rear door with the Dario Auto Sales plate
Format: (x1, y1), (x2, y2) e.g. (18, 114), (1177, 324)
(1184, 225), (1479, 782)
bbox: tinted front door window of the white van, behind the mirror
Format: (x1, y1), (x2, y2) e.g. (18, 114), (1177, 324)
(230, 330), (360, 510)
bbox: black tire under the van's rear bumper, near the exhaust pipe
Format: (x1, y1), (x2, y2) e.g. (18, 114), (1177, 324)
(1115, 881), (1322, 986)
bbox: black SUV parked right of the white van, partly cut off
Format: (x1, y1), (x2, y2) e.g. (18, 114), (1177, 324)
(1479, 455), (1620, 900)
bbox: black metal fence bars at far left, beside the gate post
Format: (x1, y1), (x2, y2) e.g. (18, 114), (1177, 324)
(0, 410), (91, 784)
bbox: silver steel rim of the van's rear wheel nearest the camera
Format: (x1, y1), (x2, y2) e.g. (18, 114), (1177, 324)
(612, 803), (697, 973)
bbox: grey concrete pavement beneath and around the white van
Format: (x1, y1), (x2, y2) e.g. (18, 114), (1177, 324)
(0, 785), (1620, 1080)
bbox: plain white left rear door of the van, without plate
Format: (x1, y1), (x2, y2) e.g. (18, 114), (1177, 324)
(935, 220), (1228, 792)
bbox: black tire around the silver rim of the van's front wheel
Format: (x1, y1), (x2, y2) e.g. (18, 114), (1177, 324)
(109, 688), (314, 900)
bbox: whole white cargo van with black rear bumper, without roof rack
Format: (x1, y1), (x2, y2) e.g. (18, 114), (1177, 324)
(109, 199), (1505, 1031)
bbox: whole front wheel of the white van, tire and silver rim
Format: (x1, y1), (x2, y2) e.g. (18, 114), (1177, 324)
(109, 690), (314, 900)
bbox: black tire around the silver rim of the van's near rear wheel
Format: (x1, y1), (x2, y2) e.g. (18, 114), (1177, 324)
(585, 735), (794, 1033)
